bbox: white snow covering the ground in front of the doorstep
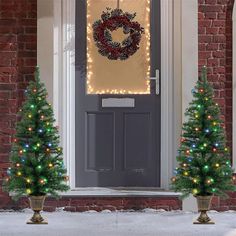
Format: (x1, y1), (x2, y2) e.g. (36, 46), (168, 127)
(0, 210), (236, 236)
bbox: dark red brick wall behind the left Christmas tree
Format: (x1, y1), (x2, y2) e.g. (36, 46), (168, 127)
(0, 0), (37, 207)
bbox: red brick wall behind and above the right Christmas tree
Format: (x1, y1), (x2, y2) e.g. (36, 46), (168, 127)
(198, 0), (234, 148)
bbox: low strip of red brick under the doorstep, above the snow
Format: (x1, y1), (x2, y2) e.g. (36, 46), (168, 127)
(4, 196), (182, 212)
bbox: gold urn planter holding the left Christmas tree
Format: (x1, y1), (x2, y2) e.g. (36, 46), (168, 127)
(27, 196), (48, 224)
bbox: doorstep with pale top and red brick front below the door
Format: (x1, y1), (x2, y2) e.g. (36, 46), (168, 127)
(56, 188), (182, 212)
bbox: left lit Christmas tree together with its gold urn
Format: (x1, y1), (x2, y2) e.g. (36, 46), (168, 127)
(4, 67), (69, 224)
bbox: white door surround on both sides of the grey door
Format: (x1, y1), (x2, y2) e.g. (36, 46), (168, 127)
(49, 0), (198, 195)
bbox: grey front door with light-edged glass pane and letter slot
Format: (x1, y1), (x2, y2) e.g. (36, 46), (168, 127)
(75, 0), (160, 187)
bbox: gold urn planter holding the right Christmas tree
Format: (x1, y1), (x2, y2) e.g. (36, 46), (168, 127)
(194, 196), (215, 224)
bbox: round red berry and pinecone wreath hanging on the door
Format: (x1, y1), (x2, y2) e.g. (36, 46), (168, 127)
(93, 8), (144, 60)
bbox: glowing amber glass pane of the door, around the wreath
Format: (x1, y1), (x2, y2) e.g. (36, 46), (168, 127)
(87, 0), (150, 94)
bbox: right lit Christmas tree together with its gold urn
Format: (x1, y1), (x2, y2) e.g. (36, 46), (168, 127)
(172, 67), (235, 224)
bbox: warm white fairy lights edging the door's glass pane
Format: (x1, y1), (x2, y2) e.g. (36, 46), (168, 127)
(87, 0), (151, 94)
